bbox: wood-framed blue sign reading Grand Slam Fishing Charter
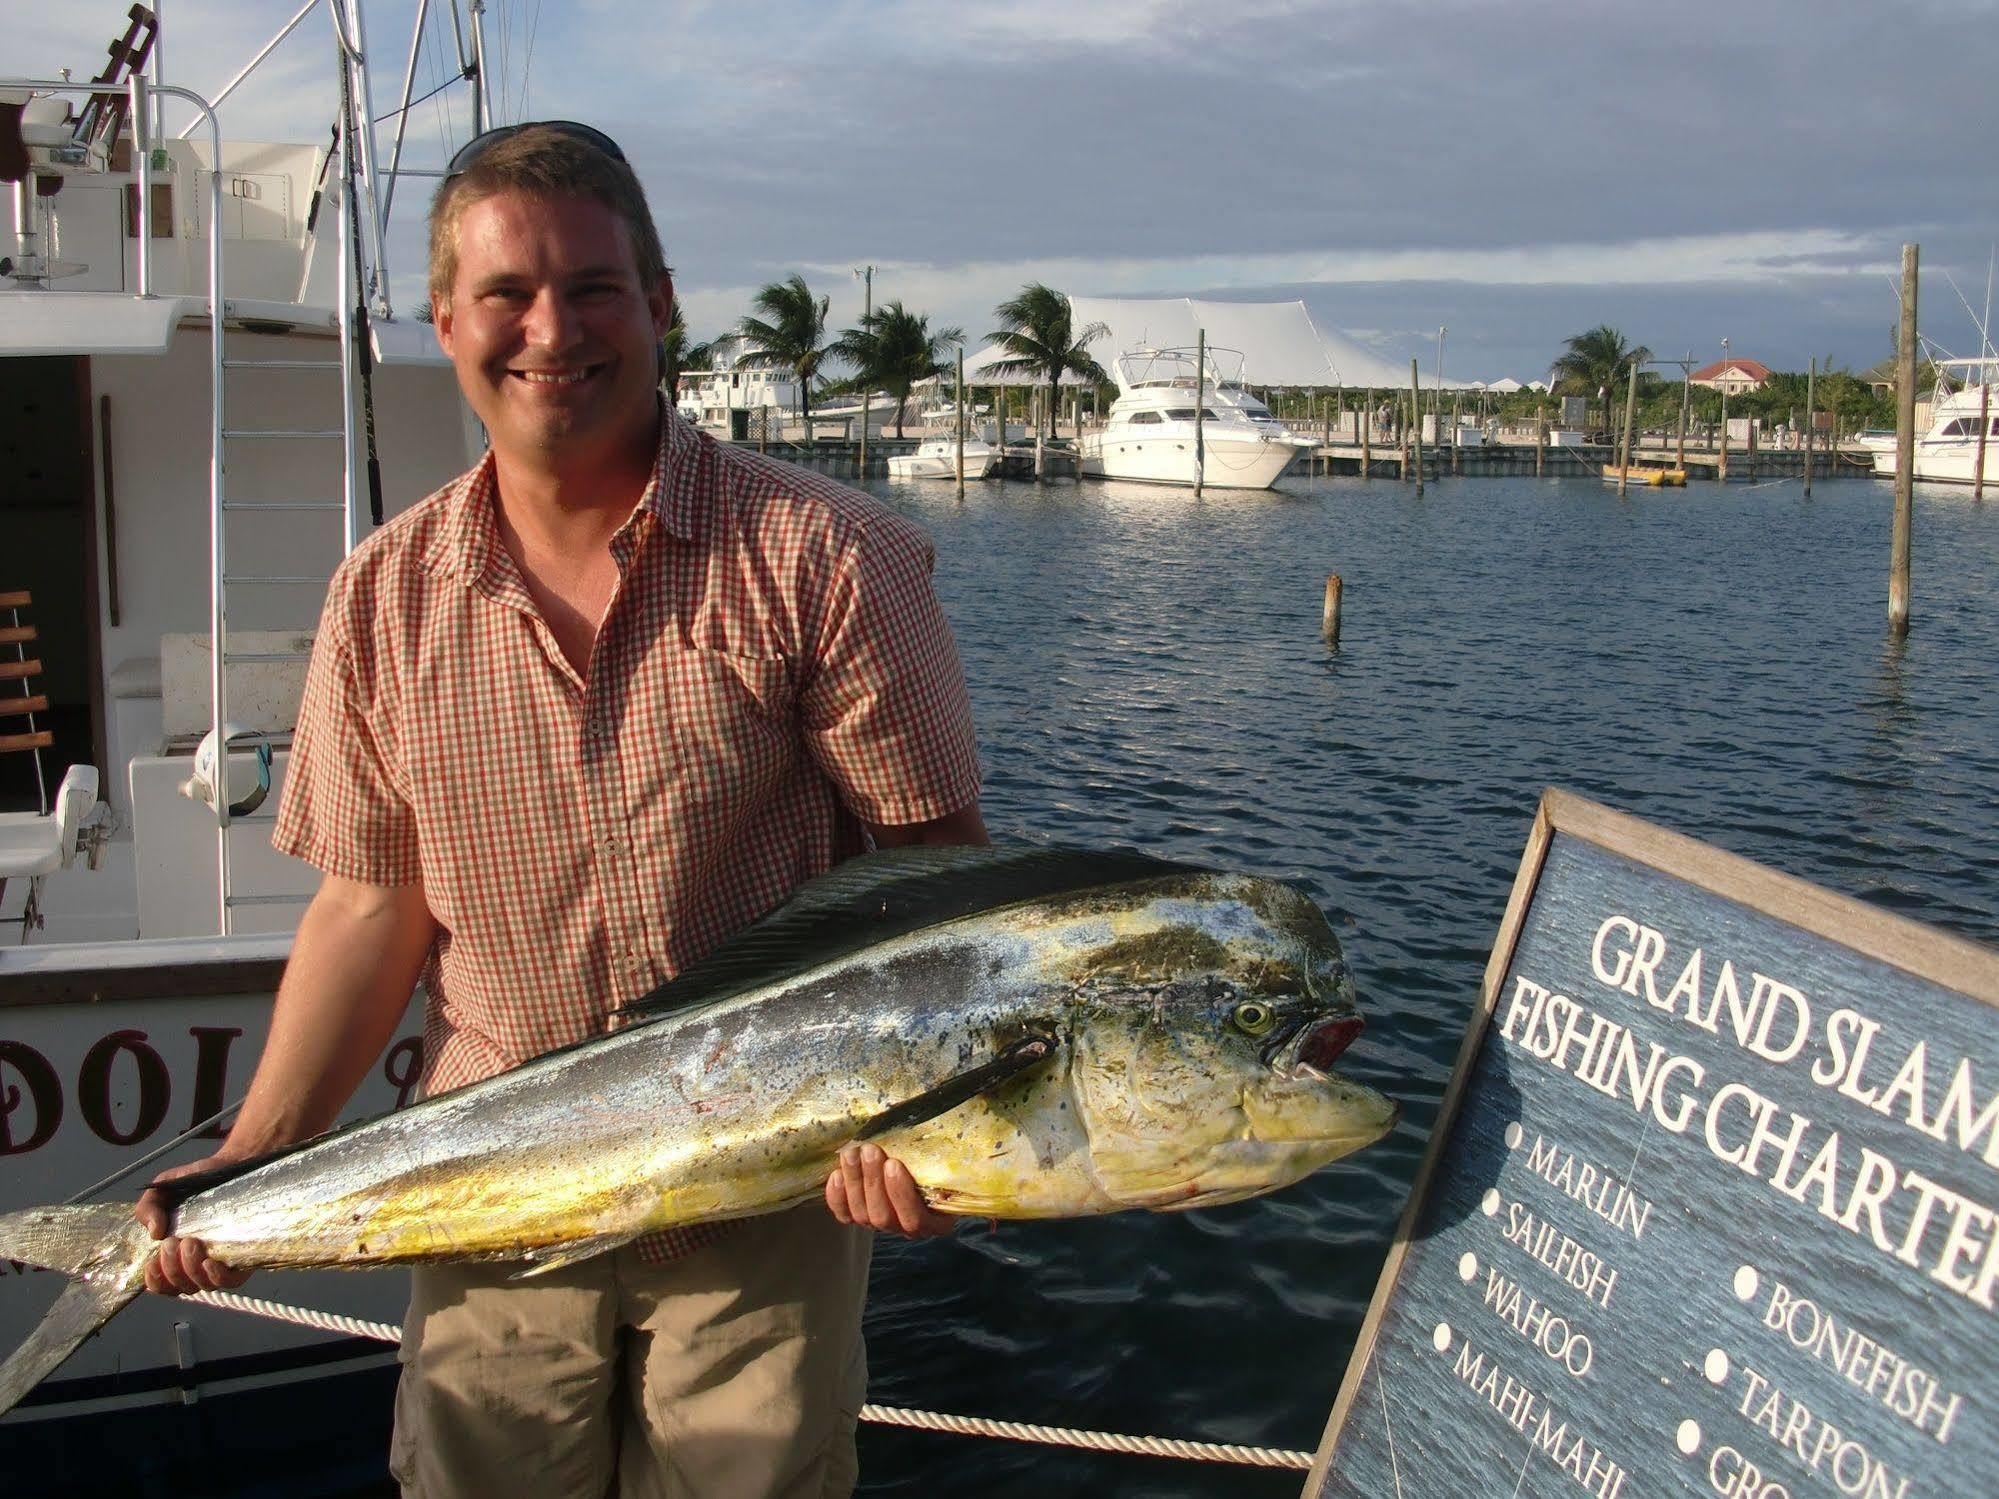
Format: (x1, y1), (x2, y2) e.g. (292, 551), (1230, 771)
(1305, 791), (1999, 1499)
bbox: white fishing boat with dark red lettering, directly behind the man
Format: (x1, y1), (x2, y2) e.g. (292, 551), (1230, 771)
(0, 0), (484, 1493)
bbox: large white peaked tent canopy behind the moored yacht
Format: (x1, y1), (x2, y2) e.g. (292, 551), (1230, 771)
(1069, 296), (1435, 390)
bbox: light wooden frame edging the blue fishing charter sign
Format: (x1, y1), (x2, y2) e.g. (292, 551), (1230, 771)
(1303, 787), (1999, 1499)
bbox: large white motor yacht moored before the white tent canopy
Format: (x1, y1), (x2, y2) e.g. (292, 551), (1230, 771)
(1081, 348), (1303, 490)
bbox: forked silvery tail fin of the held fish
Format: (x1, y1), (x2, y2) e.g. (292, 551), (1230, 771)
(0, 1203), (154, 1415)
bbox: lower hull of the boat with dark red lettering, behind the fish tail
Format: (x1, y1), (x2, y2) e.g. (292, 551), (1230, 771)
(0, 935), (424, 1461)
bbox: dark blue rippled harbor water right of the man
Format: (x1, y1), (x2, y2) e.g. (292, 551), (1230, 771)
(862, 478), (1999, 1499)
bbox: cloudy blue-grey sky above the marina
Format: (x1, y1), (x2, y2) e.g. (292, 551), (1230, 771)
(19, 0), (1999, 380)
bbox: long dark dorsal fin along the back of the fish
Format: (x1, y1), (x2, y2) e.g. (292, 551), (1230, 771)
(622, 845), (1193, 1019)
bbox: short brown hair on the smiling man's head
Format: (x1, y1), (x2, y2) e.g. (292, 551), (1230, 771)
(430, 124), (666, 312)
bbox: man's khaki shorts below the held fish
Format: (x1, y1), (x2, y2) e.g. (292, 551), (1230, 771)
(390, 1201), (874, 1499)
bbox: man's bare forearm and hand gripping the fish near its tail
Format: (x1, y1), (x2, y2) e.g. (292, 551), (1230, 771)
(136, 875), (438, 1295)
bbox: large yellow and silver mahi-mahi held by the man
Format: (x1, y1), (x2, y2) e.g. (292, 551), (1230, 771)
(0, 847), (1397, 1411)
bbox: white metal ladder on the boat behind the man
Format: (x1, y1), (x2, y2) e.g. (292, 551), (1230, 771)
(210, 87), (364, 935)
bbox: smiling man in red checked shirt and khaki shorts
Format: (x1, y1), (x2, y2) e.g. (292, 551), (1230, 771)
(140, 122), (986, 1499)
